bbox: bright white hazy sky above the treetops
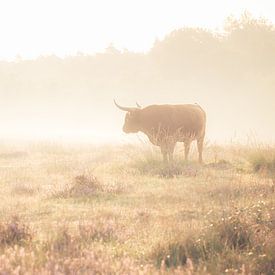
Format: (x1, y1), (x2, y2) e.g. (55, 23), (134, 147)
(0, 0), (275, 59)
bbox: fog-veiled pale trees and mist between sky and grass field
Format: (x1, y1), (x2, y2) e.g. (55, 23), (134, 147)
(0, 14), (275, 142)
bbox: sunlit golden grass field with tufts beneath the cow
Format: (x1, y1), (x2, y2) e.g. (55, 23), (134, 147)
(0, 143), (275, 274)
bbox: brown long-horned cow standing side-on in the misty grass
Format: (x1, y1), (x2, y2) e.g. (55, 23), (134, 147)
(114, 101), (206, 163)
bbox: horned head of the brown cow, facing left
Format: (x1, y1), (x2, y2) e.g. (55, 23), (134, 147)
(114, 100), (141, 134)
